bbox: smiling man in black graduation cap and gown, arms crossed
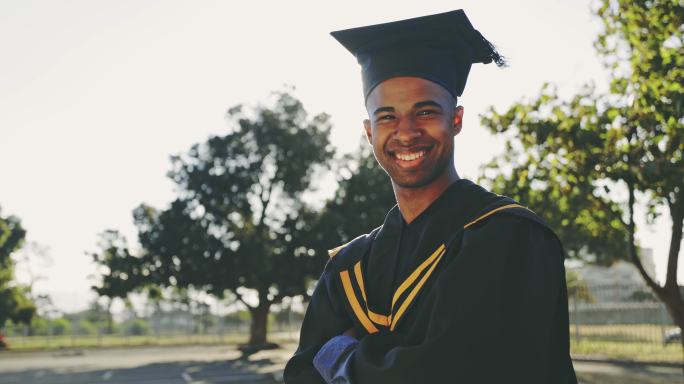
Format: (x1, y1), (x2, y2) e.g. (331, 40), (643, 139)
(284, 10), (576, 384)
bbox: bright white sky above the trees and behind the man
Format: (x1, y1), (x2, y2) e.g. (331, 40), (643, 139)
(0, 0), (684, 311)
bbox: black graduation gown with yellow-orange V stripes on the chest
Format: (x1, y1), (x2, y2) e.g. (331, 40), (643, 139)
(284, 180), (577, 384)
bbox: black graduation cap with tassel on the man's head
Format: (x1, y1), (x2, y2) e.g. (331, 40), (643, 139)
(330, 9), (506, 99)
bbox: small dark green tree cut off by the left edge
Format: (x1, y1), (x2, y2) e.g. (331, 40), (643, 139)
(0, 211), (36, 327)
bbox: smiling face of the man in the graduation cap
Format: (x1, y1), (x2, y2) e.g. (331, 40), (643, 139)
(364, 77), (463, 188)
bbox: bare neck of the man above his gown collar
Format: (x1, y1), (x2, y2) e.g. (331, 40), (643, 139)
(392, 167), (459, 223)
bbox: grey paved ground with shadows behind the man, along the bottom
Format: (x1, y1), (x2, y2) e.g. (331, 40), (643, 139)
(0, 345), (684, 384)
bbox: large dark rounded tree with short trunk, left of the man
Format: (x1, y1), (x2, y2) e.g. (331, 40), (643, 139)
(123, 92), (333, 346)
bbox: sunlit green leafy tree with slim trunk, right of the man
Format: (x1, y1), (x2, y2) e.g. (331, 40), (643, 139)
(482, 0), (684, 345)
